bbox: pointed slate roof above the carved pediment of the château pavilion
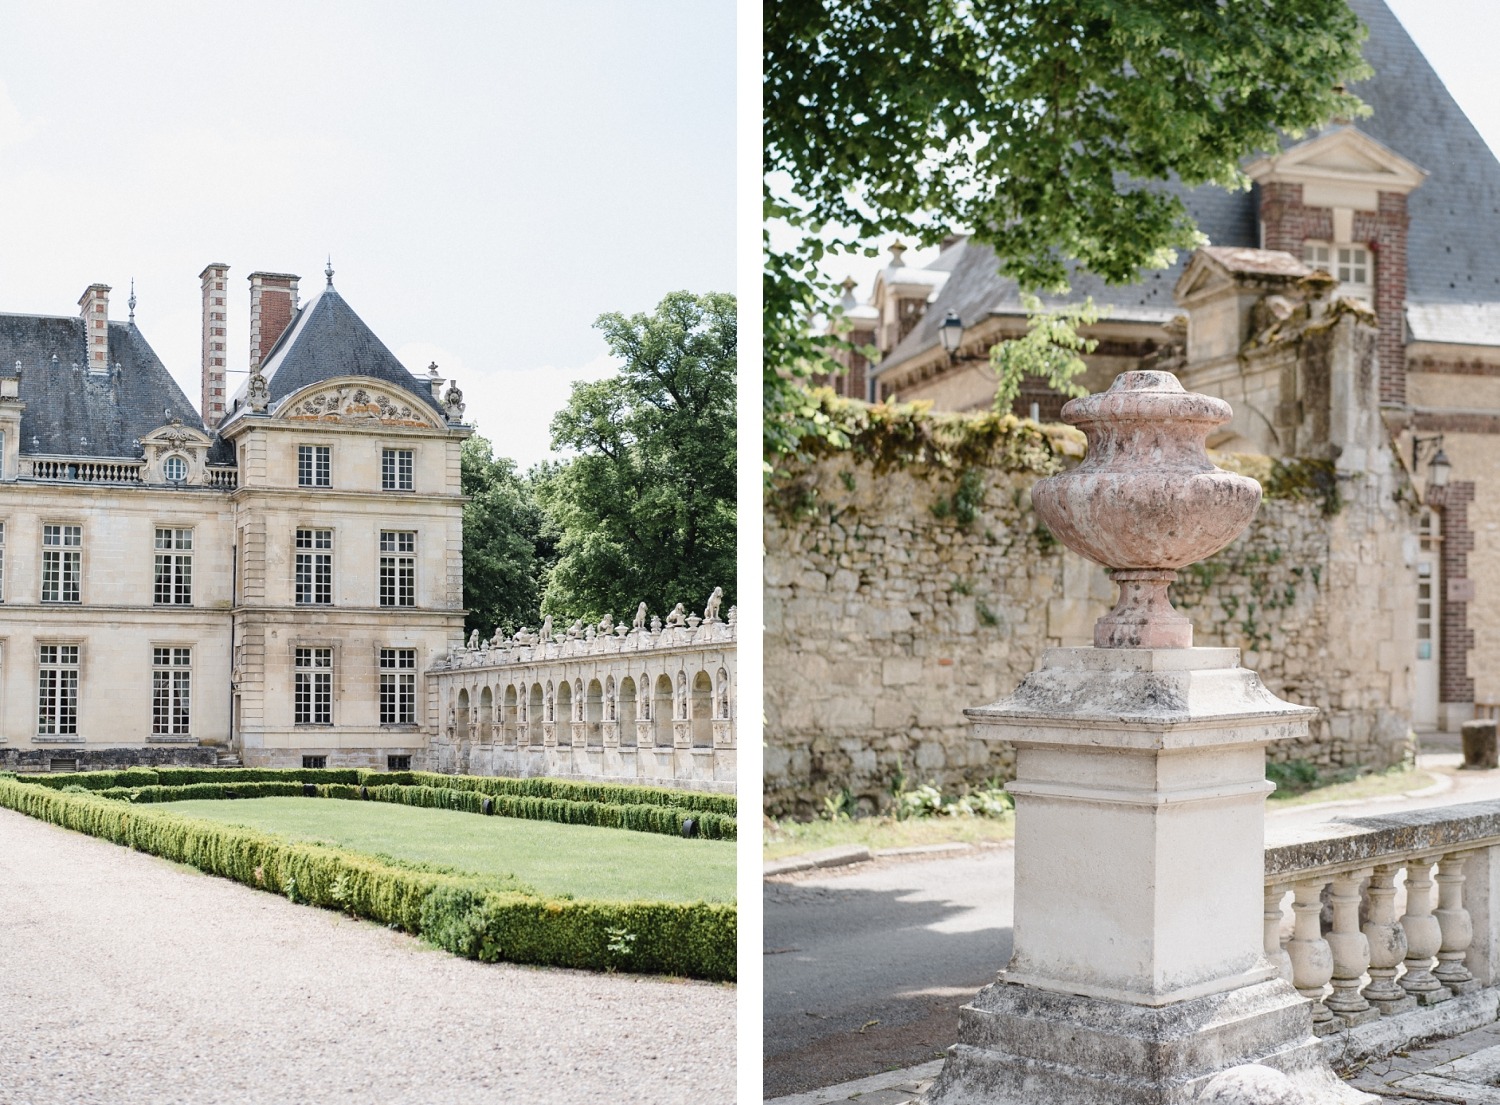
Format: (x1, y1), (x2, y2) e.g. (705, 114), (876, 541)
(231, 283), (446, 417)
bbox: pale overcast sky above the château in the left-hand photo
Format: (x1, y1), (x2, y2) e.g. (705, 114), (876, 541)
(0, 0), (735, 468)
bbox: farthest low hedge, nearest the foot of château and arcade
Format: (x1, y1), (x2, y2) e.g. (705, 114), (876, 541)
(21, 768), (737, 817)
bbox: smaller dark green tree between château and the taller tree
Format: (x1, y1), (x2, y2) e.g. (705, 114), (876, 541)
(459, 433), (557, 637)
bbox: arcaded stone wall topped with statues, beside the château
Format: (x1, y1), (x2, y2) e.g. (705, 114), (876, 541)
(428, 592), (738, 793)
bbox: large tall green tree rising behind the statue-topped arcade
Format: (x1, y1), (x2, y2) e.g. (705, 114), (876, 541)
(539, 292), (735, 621)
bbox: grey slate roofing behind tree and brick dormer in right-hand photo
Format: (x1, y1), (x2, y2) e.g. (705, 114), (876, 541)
(876, 0), (1500, 373)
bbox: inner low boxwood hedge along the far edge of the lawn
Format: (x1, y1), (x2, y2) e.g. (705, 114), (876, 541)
(85, 775), (737, 840)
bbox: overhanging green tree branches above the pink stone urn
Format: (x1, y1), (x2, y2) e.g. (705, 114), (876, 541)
(764, 0), (1368, 453)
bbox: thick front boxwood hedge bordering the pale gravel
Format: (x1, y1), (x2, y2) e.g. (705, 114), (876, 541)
(0, 778), (737, 979)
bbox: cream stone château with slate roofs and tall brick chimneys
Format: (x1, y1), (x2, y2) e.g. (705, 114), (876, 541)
(0, 265), (470, 769)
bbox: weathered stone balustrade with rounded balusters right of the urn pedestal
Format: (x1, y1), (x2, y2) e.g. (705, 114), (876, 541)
(1265, 802), (1500, 1036)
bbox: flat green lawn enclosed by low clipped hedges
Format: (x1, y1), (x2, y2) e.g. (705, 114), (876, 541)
(164, 798), (735, 901)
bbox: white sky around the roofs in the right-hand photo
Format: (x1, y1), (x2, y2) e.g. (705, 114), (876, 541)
(824, 0), (1500, 300)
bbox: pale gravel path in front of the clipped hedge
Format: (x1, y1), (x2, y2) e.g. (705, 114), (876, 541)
(0, 810), (735, 1105)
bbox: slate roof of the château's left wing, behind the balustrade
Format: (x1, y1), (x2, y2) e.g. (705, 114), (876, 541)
(0, 315), (203, 459)
